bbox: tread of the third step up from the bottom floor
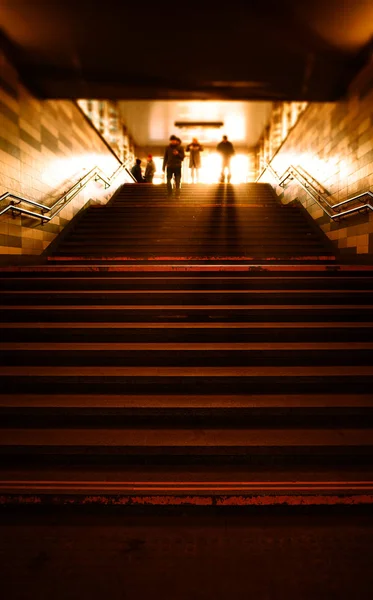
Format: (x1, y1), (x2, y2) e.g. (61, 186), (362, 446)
(0, 391), (373, 410)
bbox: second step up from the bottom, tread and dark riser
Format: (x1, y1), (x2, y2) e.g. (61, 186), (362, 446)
(0, 427), (373, 458)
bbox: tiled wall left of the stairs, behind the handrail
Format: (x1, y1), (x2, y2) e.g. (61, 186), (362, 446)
(0, 54), (122, 254)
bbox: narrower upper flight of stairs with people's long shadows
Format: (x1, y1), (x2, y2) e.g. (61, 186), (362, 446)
(50, 184), (334, 263)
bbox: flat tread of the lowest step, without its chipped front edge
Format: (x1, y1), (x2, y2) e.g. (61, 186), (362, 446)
(0, 467), (373, 495)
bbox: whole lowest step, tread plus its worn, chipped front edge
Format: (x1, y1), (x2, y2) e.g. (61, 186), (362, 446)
(0, 464), (373, 506)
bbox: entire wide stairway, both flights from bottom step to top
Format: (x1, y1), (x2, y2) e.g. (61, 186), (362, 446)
(0, 185), (373, 507)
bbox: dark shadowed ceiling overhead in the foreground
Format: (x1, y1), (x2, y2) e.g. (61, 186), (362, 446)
(0, 0), (373, 101)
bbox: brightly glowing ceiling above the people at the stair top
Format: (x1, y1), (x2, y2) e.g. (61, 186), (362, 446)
(120, 100), (272, 146)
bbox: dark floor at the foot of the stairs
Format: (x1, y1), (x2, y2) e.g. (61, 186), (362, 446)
(0, 508), (373, 600)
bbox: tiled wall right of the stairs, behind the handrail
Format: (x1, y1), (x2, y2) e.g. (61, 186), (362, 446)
(260, 64), (373, 254)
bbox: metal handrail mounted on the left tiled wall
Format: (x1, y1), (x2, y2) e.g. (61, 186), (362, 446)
(0, 163), (135, 225)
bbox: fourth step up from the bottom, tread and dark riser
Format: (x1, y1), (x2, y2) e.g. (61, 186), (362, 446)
(0, 361), (373, 395)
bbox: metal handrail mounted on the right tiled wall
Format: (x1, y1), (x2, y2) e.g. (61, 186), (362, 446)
(257, 163), (373, 220)
